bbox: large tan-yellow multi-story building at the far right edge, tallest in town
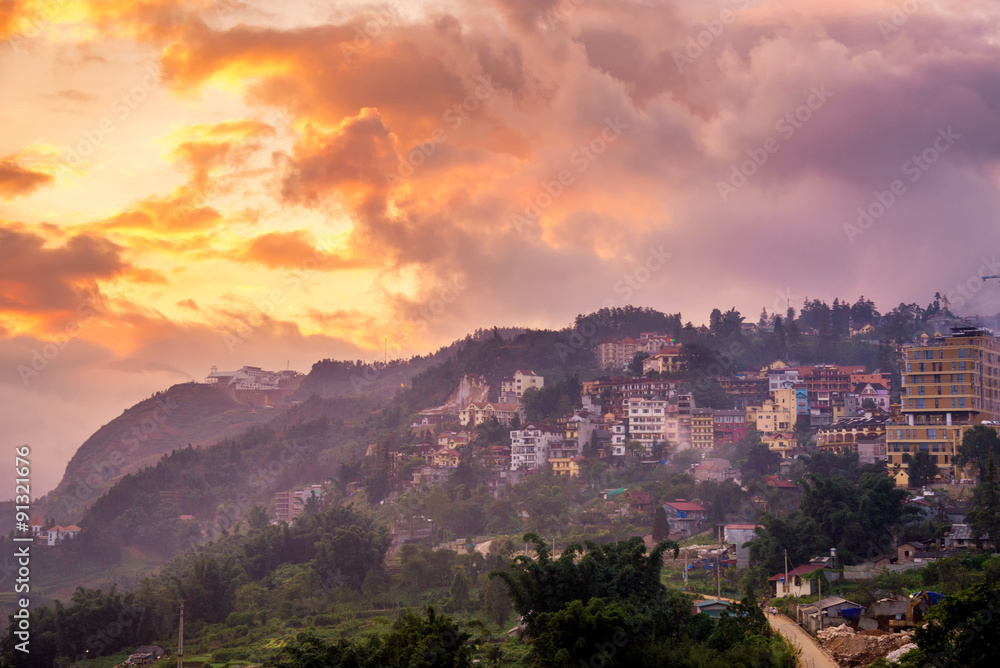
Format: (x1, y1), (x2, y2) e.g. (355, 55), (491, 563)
(886, 327), (1000, 485)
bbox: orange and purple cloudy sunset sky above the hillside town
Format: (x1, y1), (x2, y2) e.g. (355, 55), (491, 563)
(0, 0), (1000, 496)
